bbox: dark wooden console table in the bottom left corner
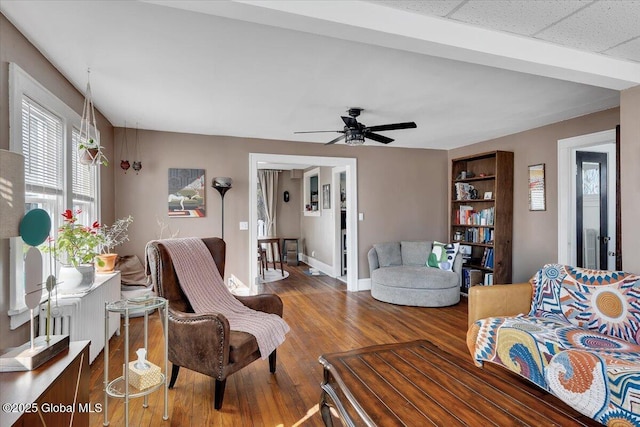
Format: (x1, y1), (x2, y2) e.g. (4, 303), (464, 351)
(0, 341), (90, 427)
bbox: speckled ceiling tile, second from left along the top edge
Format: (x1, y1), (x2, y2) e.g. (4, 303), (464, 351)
(450, 0), (591, 36)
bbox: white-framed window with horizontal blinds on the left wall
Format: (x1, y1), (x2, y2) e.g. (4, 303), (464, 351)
(9, 64), (99, 329)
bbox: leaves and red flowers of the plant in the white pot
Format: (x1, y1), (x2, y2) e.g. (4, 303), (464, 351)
(42, 209), (105, 267)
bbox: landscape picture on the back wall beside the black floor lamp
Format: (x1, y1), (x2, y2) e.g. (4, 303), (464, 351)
(167, 168), (206, 218)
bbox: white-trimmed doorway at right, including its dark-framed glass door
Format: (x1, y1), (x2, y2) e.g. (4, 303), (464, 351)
(558, 129), (617, 270)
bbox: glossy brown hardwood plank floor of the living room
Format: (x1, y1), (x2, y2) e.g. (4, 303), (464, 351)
(90, 264), (596, 427)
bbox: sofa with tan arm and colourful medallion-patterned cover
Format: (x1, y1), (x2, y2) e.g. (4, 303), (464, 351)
(467, 264), (640, 426)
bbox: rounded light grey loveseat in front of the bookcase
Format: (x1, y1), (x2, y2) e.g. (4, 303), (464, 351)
(367, 241), (462, 307)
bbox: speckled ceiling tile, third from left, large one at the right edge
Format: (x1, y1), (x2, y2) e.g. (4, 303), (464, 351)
(536, 1), (640, 53)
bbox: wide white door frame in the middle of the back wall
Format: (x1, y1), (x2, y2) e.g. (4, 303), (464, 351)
(247, 153), (359, 291)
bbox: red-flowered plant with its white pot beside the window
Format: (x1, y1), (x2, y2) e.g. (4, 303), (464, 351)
(42, 209), (104, 292)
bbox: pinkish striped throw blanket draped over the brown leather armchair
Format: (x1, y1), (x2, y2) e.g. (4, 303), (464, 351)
(162, 237), (289, 359)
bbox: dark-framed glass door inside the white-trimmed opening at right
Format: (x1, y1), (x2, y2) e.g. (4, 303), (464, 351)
(576, 151), (615, 270)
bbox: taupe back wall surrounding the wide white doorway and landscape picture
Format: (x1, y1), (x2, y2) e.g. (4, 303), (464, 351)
(115, 128), (447, 283)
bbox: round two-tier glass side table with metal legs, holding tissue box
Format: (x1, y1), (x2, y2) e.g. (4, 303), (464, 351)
(103, 296), (169, 427)
